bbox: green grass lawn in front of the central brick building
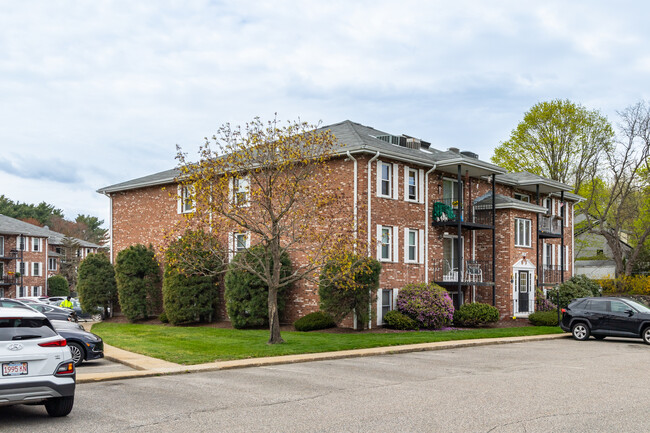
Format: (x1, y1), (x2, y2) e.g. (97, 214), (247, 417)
(93, 323), (562, 365)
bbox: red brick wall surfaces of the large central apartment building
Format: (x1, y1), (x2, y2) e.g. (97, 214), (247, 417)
(107, 156), (572, 327)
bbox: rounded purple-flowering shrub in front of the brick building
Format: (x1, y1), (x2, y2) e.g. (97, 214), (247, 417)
(397, 283), (454, 329)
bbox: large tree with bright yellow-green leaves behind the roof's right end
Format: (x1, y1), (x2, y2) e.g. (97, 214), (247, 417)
(492, 99), (614, 191)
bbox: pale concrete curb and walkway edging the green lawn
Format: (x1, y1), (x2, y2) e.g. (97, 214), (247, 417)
(77, 334), (571, 384)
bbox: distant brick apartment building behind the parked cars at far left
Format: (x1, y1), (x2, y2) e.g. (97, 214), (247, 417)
(0, 215), (101, 298)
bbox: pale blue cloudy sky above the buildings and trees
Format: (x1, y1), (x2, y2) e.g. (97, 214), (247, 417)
(0, 0), (650, 227)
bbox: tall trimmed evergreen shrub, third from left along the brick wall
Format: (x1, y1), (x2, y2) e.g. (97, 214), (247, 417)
(163, 230), (224, 325)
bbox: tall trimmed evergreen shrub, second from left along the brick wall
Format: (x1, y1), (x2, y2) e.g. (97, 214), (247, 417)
(115, 244), (161, 321)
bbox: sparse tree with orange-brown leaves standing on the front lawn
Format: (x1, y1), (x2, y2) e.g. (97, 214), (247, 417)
(178, 118), (354, 344)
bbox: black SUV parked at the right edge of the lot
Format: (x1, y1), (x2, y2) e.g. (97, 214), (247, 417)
(560, 297), (650, 344)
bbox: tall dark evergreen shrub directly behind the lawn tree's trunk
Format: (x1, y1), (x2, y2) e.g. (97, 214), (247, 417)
(224, 247), (291, 329)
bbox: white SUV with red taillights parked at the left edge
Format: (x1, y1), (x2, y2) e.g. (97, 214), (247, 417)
(0, 307), (76, 416)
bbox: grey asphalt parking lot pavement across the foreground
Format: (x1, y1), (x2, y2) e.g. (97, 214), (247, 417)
(0, 339), (650, 433)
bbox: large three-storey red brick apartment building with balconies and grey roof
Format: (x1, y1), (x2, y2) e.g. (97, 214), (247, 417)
(98, 121), (580, 326)
